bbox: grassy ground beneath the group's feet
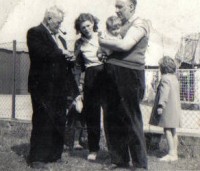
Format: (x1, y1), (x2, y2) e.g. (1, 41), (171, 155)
(0, 120), (200, 171)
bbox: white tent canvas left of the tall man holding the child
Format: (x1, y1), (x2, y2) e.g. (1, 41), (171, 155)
(0, 0), (114, 43)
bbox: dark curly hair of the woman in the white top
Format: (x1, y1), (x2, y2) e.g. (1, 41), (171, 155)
(74, 13), (99, 34)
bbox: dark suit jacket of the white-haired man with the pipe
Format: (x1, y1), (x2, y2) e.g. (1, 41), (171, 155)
(27, 24), (77, 98)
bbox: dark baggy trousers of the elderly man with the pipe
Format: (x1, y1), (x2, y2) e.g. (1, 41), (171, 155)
(28, 91), (66, 162)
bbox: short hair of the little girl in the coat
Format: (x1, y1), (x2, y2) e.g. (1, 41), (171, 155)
(158, 56), (176, 74)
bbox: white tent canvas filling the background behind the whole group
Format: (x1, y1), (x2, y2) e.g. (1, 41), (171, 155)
(0, 0), (200, 65)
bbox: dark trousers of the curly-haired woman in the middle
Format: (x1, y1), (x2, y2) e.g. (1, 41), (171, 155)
(83, 65), (104, 152)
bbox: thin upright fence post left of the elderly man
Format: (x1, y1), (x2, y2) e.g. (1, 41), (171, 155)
(12, 40), (17, 119)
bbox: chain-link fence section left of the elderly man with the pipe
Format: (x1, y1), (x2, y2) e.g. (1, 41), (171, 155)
(0, 42), (32, 120)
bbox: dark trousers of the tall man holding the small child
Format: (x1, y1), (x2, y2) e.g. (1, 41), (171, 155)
(104, 64), (147, 168)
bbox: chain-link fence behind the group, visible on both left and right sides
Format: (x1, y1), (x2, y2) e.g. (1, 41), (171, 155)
(0, 40), (200, 136)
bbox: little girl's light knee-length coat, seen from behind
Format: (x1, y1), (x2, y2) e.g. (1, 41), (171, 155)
(149, 74), (181, 128)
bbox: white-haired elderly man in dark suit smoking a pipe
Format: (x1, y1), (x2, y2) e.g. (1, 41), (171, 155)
(27, 6), (78, 167)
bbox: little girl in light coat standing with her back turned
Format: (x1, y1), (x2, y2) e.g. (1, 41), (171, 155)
(150, 56), (181, 161)
